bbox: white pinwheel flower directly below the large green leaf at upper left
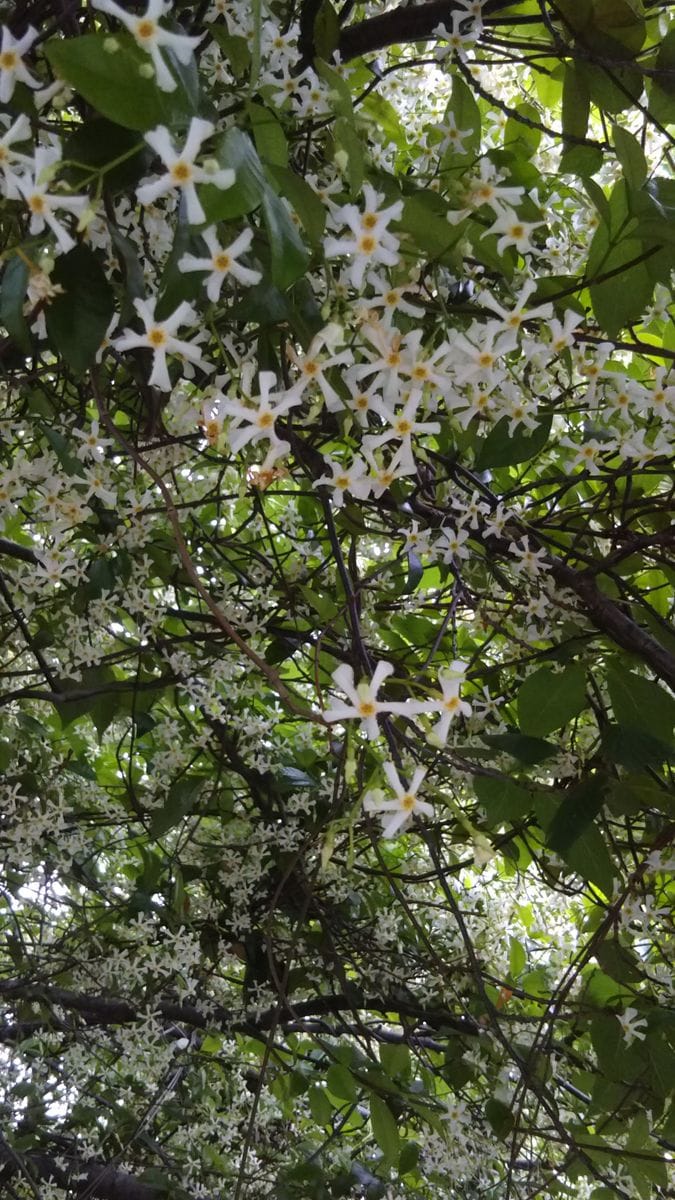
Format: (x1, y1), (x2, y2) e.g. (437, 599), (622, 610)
(136, 116), (234, 224)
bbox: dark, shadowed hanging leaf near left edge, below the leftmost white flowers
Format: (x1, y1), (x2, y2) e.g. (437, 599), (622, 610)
(46, 245), (115, 374)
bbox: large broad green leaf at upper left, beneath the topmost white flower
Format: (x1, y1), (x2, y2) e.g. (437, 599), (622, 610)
(42, 32), (196, 132)
